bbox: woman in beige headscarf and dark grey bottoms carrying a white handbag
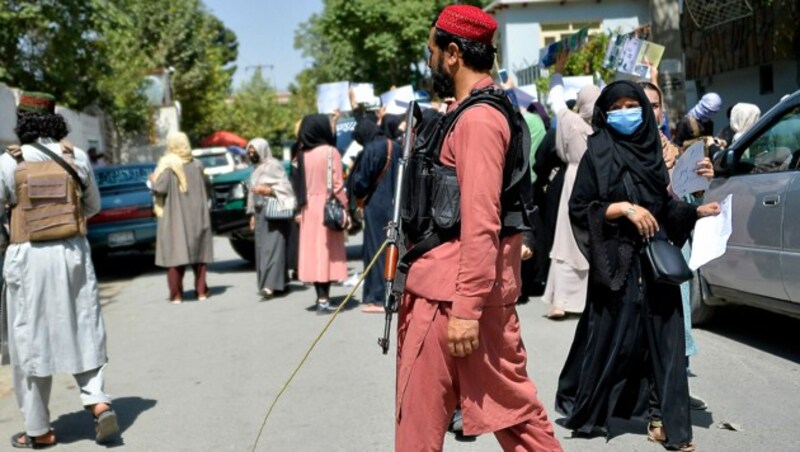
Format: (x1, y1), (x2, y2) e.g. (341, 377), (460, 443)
(247, 138), (296, 299)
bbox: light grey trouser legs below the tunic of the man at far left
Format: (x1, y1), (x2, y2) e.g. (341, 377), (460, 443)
(12, 366), (111, 436)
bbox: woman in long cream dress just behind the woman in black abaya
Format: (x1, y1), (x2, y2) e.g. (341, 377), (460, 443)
(542, 70), (600, 319)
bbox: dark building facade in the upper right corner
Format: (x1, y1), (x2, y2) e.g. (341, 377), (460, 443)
(681, 0), (800, 129)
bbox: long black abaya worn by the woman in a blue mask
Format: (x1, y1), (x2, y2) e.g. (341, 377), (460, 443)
(556, 144), (697, 444)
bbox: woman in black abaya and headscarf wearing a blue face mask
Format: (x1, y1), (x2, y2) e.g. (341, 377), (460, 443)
(556, 81), (720, 451)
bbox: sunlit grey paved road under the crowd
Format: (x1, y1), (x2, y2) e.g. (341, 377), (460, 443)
(0, 239), (800, 452)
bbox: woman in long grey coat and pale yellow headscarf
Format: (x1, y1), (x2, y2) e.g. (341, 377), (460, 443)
(150, 132), (214, 304)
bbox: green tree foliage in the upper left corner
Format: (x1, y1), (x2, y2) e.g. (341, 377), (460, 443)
(0, 0), (238, 141)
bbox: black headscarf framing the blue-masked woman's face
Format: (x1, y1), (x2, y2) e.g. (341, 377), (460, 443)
(589, 80), (669, 203)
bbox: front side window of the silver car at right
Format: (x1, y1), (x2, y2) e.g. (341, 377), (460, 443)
(737, 107), (800, 173)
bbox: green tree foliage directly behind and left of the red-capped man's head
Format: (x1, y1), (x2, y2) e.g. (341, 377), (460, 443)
(295, 0), (490, 104)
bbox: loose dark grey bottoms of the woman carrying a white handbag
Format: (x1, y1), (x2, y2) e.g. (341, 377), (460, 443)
(255, 211), (292, 291)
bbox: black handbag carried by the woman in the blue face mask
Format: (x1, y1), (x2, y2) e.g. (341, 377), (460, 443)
(623, 173), (694, 286)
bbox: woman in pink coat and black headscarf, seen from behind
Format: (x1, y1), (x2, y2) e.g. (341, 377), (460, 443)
(295, 115), (350, 314)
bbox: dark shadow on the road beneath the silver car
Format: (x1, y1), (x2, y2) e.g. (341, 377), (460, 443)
(701, 306), (800, 364)
